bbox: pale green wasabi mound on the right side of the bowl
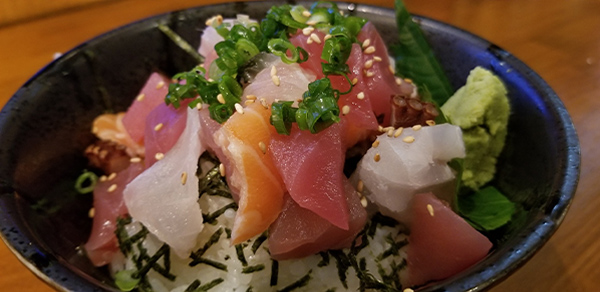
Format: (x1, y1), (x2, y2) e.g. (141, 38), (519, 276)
(441, 67), (510, 190)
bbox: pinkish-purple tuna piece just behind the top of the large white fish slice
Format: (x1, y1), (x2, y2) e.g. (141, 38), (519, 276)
(144, 100), (189, 168)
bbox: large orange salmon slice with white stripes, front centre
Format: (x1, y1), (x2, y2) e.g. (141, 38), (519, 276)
(215, 103), (285, 244)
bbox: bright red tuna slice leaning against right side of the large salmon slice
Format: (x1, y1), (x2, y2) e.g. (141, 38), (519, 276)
(269, 123), (349, 230)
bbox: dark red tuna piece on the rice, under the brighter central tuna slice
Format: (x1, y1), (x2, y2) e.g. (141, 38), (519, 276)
(269, 180), (367, 260)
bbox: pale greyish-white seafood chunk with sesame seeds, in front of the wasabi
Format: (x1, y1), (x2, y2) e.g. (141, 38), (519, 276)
(351, 124), (465, 223)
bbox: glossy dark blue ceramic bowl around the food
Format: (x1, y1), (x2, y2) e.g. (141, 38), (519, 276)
(0, 1), (580, 291)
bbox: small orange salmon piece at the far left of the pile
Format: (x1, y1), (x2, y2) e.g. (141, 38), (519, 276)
(92, 113), (144, 157)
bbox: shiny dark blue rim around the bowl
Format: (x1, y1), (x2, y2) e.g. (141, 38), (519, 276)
(0, 1), (581, 291)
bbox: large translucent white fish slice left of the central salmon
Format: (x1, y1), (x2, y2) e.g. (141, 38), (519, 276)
(123, 108), (204, 258)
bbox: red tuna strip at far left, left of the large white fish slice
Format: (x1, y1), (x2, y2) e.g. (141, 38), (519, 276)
(84, 163), (144, 267)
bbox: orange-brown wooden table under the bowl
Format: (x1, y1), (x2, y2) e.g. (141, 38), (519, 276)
(0, 0), (600, 291)
